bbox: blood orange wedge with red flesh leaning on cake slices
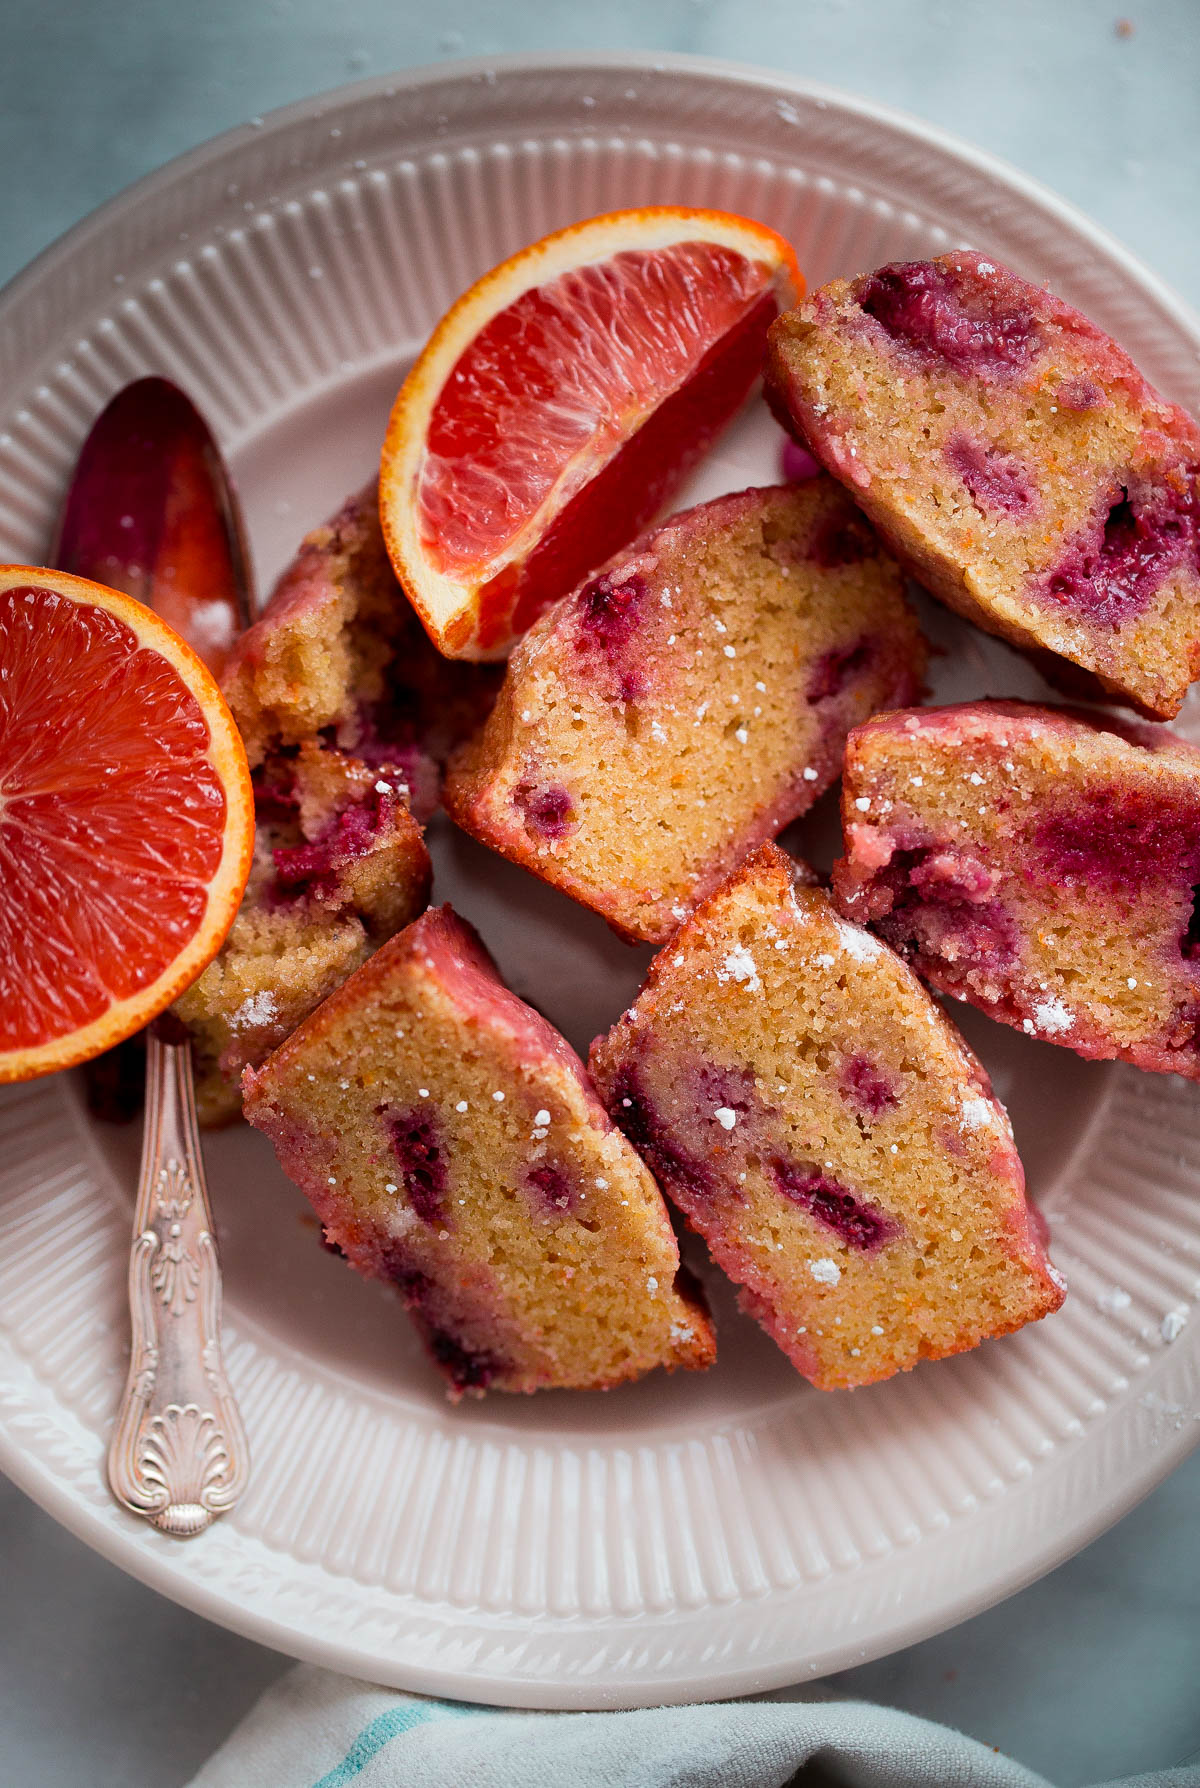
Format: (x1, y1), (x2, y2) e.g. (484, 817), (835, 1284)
(379, 206), (803, 658)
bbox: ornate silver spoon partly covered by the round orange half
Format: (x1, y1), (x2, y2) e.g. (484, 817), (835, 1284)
(54, 379), (254, 1539)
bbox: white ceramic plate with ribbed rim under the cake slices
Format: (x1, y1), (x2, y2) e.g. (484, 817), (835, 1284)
(0, 57), (1200, 1708)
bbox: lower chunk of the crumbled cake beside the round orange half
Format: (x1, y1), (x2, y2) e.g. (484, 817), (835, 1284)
(173, 740), (429, 1125)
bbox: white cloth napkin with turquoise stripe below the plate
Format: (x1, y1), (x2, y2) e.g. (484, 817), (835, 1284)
(190, 1665), (1200, 1788)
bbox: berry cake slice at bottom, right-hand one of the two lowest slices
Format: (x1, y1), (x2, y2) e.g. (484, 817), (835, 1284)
(592, 844), (1062, 1389)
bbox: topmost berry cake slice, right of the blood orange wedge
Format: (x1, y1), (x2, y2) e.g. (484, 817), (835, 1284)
(767, 250), (1200, 719)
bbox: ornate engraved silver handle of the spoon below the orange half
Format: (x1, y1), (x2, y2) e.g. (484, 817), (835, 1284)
(109, 1019), (250, 1539)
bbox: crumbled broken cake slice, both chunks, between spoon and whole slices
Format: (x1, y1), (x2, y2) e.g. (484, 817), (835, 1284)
(175, 485), (497, 1125)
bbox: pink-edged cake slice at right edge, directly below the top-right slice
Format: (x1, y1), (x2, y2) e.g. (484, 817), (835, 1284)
(833, 701), (1200, 1080)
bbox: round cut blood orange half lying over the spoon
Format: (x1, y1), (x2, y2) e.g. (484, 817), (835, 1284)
(0, 565), (254, 1080)
